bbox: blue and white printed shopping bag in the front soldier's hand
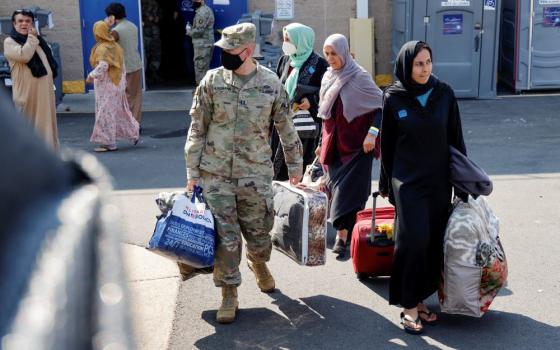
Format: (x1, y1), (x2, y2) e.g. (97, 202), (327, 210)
(148, 186), (216, 268)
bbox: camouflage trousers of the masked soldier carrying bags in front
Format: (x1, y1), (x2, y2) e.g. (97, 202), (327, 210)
(201, 172), (274, 287)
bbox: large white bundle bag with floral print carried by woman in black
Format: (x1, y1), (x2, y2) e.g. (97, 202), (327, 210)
(439, 196), (508, 317)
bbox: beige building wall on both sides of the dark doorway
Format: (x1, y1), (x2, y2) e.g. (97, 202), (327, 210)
(0, 0), (392, 91)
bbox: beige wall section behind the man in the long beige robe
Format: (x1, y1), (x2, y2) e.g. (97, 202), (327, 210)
(0, 0), (83, 81)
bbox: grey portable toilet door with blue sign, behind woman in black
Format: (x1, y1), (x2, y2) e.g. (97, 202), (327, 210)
(425, 0), (483, 97)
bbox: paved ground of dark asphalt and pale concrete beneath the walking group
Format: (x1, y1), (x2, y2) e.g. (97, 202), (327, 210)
(59, 93), (560, 350)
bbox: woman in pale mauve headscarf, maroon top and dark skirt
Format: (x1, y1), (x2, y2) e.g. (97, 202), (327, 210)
(317, 34), (382, 255)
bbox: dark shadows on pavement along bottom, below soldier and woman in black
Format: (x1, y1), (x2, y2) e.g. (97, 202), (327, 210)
(195, 291), (560, 349)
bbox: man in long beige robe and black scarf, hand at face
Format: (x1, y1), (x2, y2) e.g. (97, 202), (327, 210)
(4, 10), (58, 150)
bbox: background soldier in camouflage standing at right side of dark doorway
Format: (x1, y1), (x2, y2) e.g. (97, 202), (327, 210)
(187, 0), (214, 84)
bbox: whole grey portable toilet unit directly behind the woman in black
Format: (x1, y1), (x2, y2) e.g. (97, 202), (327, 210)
(393, 0), (499, 98)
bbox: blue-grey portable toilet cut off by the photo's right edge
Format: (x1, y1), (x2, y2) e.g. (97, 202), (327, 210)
(500, 0), (560, 92)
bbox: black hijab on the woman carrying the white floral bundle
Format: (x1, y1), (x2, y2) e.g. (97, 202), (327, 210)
(388, 41), (439, 97)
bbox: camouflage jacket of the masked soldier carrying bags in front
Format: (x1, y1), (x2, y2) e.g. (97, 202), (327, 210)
(185, 64), (302, 179)
